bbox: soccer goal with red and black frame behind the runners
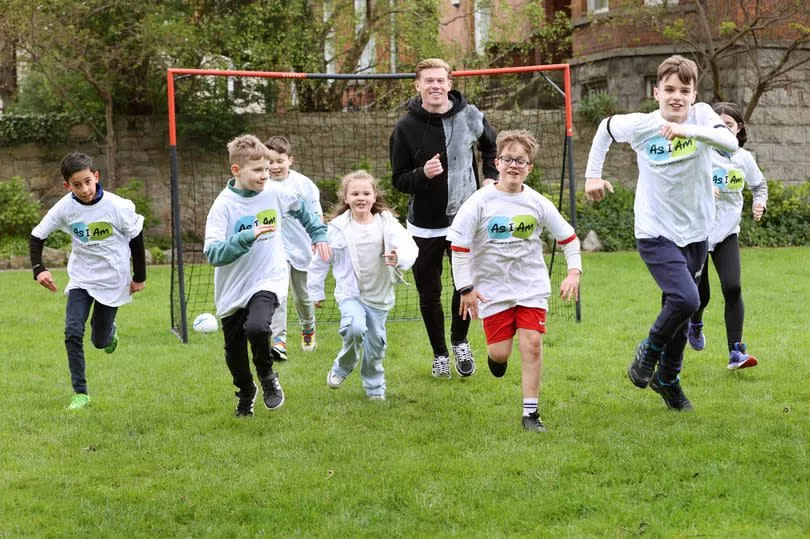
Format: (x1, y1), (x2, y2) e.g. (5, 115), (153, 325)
(167, 64), (581, 342)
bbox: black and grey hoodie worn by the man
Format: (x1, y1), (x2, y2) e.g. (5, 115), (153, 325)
(389, 90), (498, 228)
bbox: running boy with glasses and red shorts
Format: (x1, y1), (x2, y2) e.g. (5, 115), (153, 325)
(447, 130), (582, 432)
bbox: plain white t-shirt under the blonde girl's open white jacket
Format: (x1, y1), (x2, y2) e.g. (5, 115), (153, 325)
(345, 219), (394, 310)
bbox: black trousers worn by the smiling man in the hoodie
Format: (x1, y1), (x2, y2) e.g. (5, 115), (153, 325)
(411, 236), (470, 356)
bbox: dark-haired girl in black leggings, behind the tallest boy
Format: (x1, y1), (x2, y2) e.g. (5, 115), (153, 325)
(687, 103), (768, 370)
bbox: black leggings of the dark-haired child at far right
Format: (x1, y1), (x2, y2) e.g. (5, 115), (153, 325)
(692, 234), (745, 350)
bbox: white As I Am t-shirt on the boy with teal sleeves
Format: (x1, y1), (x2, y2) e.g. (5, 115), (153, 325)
(204, 182), (301, 318)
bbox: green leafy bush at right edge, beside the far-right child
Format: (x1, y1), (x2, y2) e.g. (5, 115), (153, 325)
(740, 180), (810, 247)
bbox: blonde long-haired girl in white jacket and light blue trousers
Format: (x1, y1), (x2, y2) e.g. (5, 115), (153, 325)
(307, 170), (418, 400)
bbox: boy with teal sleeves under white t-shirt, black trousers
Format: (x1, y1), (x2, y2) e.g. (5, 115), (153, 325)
(203, 135), (329, 417)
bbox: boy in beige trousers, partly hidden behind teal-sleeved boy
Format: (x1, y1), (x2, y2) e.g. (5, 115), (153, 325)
(264, 136), (323, 361)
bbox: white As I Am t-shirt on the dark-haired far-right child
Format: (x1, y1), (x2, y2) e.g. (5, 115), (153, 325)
(709, 148), (763, 251)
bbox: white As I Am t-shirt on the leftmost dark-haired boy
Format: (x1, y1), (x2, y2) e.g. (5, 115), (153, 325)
(31, 191), (143, 307)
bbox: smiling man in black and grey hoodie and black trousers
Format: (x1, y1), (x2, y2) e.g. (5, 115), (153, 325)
(389, 58), (498, 378)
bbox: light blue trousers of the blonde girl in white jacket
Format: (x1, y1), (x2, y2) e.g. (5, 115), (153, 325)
(332, 299), (388, 397)
